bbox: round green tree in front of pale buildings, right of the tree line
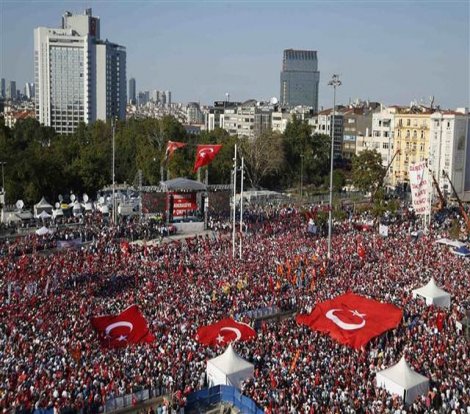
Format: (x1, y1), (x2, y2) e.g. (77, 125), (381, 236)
(352, 150), (385, 194)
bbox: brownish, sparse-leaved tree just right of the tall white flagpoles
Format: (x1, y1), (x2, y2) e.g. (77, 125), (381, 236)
(240, 131), (284, 188)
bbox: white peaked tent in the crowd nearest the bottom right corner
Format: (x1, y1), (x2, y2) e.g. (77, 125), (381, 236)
(377, 356), (429, 404)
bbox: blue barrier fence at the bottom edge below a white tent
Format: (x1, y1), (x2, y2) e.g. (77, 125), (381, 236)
(185, 385), (264, 414)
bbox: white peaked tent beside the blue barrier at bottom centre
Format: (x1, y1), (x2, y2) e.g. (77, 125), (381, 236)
(206, 344), (255, 389)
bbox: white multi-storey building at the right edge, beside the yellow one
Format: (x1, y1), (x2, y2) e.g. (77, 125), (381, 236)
(428, 108), (470, 195)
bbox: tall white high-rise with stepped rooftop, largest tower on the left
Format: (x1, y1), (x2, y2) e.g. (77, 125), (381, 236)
(34, 9), (126, 134)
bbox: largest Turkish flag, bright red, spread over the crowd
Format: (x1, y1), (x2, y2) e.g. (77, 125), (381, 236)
(296, 292), (403, 349)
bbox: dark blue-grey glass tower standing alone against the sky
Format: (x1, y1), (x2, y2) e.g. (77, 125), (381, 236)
(281, 49), (320, 112)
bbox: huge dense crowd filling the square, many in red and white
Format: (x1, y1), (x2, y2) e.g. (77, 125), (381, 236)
(0, 207), (470, 413)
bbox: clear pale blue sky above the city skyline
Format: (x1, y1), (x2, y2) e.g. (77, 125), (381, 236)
(0, 0), (470, 108)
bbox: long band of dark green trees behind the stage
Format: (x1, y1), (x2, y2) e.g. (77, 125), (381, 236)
(0, 116), (386, 205)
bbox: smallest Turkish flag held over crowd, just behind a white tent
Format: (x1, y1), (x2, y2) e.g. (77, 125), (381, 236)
(196, 318), (256, 346)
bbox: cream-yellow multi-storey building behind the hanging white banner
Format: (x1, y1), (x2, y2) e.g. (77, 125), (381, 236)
(391, 105), (434, 186)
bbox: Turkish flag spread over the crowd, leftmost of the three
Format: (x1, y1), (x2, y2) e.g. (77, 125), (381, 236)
(91, 305), (155, 348)
